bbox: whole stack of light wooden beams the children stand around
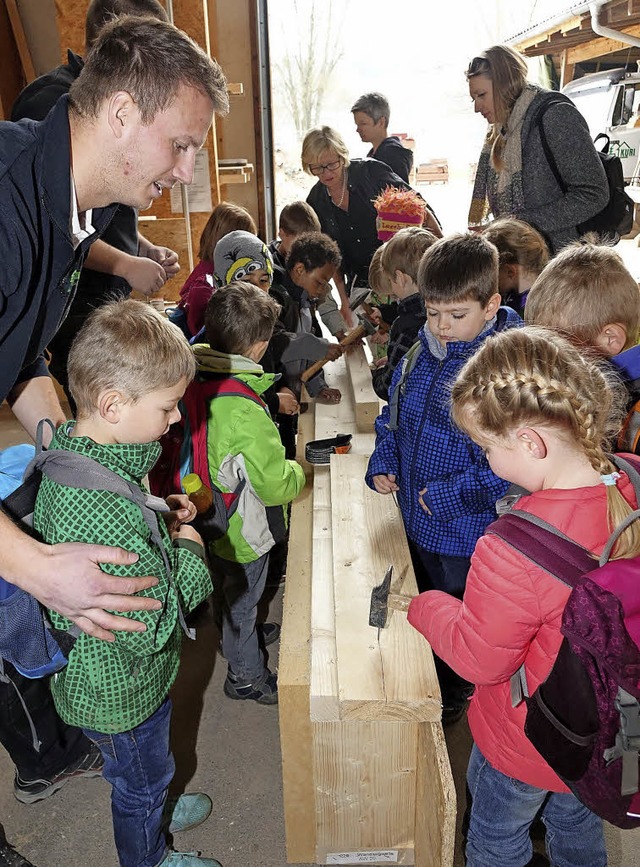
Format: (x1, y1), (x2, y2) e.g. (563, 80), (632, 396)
(278, 360), (455, 867)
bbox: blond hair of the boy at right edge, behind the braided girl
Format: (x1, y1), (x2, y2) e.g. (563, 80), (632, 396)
(524, 244), (640, 349)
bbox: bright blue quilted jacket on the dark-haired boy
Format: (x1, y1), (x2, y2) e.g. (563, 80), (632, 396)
(366, 307), (522, 557)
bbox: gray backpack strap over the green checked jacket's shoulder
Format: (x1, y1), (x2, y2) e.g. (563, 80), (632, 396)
(33, 449), (196, 639)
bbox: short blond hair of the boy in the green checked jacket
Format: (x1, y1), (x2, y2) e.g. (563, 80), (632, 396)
(68, 299), (196, 418)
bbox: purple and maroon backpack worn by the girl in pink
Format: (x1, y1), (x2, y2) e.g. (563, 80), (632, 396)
(487, 456), (640, 828)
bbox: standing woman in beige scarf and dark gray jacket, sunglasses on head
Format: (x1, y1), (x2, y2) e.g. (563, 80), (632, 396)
(465, 45), (609, 253)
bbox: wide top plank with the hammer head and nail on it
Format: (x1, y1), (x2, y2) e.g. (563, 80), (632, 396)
(331, 455), (441, 721)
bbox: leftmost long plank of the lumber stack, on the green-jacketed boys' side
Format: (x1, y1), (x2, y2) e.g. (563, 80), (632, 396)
(278, 407), (315, 864)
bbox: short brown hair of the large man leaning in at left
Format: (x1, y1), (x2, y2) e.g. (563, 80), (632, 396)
(69, 15), (229, 124)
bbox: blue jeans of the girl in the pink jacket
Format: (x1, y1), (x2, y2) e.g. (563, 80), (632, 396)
(466, 744), (607, 867)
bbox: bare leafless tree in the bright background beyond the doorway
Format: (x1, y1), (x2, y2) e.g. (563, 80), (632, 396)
(275, 0), (344, 138)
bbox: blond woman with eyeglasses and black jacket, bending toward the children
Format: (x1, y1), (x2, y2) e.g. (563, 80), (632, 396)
(302, 126), (442, 324)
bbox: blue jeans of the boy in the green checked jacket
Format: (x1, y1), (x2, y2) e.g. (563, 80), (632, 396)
(84, 699), (175, 867)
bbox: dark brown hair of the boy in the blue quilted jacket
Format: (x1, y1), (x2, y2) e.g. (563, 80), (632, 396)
(417, 232), (498, 307)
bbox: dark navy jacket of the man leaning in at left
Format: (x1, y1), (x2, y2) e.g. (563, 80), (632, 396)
(0, 97), (116, 400)
